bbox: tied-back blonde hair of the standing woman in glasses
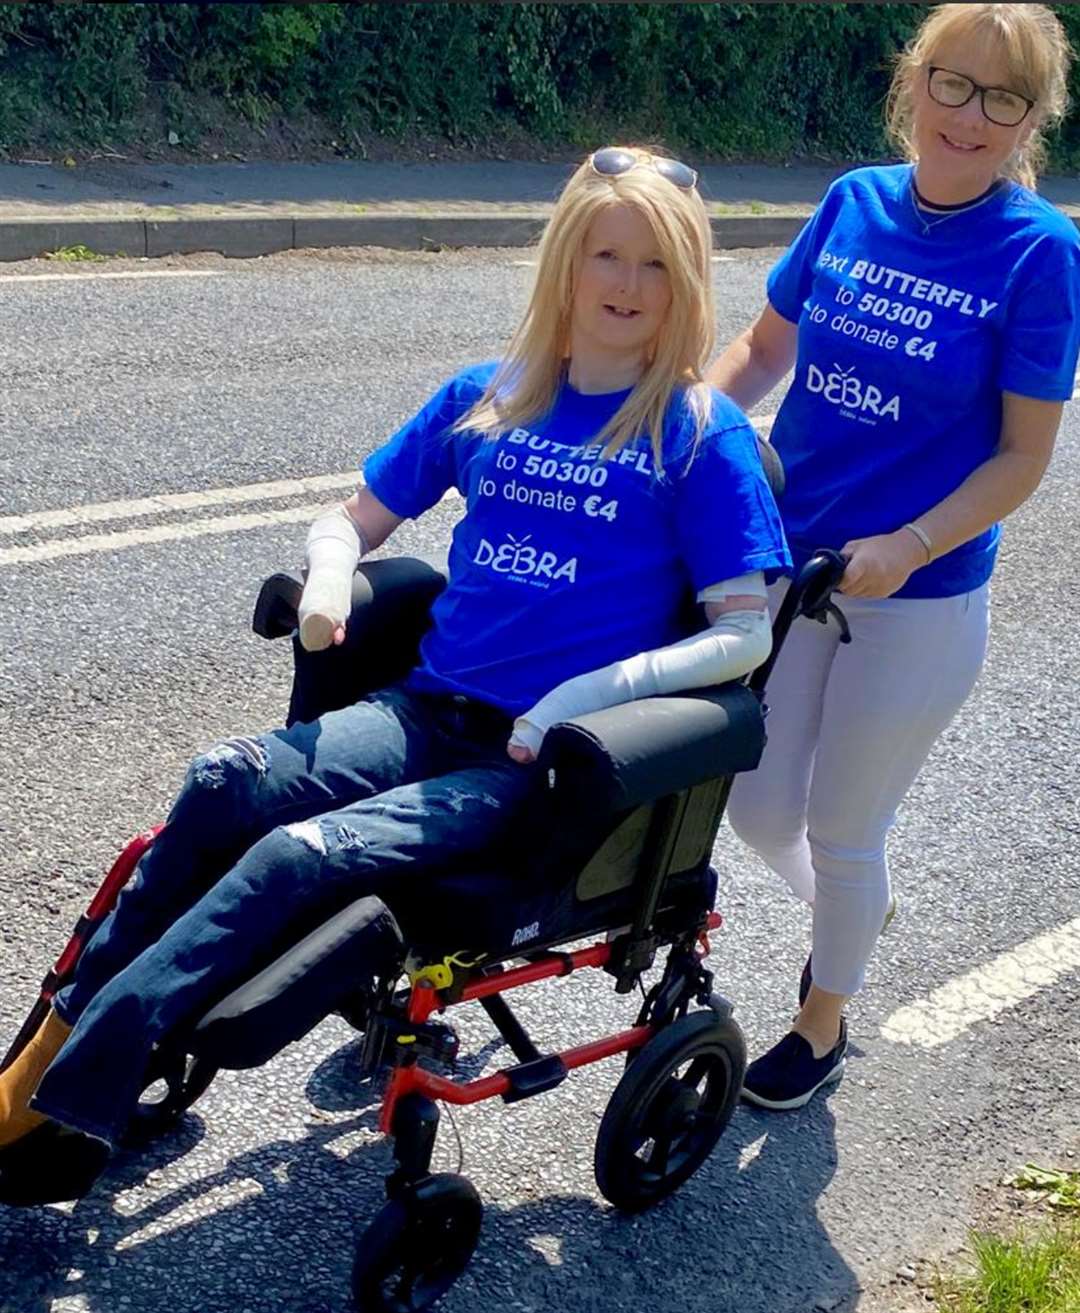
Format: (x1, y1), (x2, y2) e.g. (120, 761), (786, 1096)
(886, 4), (1072, 190)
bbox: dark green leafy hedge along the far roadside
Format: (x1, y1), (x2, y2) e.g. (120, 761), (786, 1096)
(0, 3), (1080, 167)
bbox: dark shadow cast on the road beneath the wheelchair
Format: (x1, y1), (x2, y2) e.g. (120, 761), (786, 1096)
(0, 1044), (857, 1313)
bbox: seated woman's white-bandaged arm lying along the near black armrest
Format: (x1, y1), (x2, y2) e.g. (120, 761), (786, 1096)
(510, 570), (773, 756)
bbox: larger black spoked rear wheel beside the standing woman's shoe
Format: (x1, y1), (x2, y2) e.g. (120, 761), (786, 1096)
(594, 1010), (747, 1212)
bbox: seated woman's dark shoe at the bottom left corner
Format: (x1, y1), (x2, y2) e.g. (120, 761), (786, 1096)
(0, 1121), (110, 1208)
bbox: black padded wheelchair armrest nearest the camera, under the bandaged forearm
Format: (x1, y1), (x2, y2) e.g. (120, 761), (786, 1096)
(539, 683), (765, 813)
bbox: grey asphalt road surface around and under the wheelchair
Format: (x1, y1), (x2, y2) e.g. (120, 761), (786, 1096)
(0, 252), (1080, 1313)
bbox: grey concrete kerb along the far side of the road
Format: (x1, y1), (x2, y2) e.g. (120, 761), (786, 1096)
(0, 210), (806, 261)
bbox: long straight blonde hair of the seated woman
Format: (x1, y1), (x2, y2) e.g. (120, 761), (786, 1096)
(454, 147), (715, 469)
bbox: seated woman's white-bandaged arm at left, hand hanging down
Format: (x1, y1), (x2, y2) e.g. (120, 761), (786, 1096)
(297, 488), (402, 651)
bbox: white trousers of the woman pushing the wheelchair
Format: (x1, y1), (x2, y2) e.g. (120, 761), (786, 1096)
(727, 580), (989, 995)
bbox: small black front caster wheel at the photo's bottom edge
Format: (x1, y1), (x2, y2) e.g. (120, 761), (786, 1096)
(353, 1171), (483, 1313)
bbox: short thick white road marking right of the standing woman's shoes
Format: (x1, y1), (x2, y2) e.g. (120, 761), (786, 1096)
(882, 916), (1080, 1049)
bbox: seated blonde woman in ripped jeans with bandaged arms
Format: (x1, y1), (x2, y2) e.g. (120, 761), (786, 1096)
(0, 147), (789, 1201)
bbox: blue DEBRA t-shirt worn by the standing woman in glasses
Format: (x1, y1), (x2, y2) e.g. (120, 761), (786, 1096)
(769, 164), (1080, 597)
